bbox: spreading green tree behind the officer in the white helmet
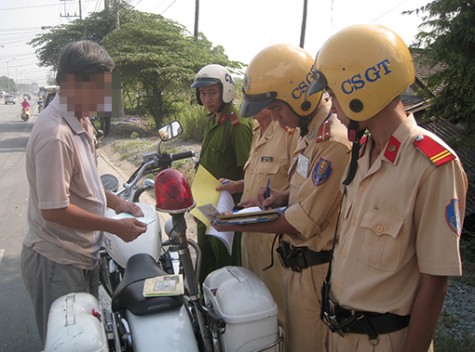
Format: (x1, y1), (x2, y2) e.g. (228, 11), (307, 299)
(102, 12), (241, 127)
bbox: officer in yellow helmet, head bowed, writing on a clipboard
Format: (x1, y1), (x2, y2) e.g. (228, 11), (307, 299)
(214, 44), (351, 352)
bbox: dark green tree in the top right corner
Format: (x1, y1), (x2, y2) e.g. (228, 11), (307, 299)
(405, 0), (475, 140)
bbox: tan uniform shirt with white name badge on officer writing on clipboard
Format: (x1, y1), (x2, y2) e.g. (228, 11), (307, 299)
(284, 102), (351, 252)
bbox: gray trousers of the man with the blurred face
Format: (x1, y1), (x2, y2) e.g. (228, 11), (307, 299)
(21, 246), (99, 344)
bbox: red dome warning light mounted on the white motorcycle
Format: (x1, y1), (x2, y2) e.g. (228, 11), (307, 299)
(154, 169), (196, 214)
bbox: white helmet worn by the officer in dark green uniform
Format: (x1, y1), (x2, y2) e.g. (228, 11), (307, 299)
(191, 64), (235, 105)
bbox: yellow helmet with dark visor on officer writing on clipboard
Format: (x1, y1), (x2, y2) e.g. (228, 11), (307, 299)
(241, 44), (322, 117)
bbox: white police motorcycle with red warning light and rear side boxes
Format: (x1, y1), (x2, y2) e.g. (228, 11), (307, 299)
(45, 121), (282, 352)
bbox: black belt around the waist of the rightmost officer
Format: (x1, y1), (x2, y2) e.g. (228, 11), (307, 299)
(334, 305), (411, 339)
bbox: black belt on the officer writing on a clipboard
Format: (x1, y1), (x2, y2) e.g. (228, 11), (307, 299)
(277, 241), (331, 272)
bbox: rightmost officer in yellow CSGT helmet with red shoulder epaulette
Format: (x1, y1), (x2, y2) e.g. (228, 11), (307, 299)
(309, 25), (467, 352)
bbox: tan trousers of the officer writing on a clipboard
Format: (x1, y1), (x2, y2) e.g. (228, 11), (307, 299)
(284, 264), (328, 352)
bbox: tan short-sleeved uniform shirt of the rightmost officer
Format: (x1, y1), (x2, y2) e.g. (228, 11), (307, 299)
(331, 115), (467, 315)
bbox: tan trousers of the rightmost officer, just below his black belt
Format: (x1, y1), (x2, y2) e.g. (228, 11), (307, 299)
(328, 328), (434, 352)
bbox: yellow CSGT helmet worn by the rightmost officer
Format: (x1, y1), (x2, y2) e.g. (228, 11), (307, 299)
(309, 25), (415, 121)
